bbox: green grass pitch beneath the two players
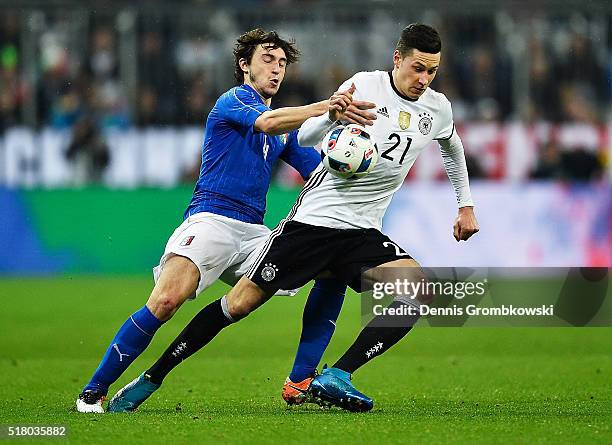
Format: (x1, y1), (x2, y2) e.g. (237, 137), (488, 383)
(0, 277), (612, 444)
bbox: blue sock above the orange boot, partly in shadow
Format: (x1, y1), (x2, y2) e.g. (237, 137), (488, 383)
(289, 278), (346, 383)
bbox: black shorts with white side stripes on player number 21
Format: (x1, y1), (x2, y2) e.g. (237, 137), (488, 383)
(246, 220), (412, 292)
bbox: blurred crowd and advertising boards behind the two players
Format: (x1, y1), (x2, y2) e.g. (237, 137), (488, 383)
(0, 0), (612, 275)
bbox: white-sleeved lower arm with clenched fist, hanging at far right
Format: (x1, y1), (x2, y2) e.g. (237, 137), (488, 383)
(438, 131), (480, 241)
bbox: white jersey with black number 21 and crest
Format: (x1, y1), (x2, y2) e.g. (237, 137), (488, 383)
(289, 71), (454, 230)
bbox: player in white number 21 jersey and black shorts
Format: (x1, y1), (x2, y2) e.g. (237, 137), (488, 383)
(111, 24), (479, 411)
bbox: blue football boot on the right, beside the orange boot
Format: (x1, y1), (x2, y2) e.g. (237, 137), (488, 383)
(309, 367), (374, 412)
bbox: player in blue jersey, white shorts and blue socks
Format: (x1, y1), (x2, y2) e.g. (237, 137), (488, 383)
(76, 28), (375, 413)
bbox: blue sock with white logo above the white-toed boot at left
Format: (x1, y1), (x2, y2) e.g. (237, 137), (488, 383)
(83, 306), (163, 394)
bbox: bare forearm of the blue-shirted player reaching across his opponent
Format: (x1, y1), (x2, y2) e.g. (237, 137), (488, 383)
(254, 100), (329, 136)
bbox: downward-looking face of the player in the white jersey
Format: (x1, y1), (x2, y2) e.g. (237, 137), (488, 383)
(393, 49), (440, 99)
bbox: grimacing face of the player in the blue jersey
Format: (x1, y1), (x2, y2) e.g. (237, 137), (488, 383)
(242, 44), (287, 99)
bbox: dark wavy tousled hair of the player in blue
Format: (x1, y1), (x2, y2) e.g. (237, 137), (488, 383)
(234, 28), (300, 85)
